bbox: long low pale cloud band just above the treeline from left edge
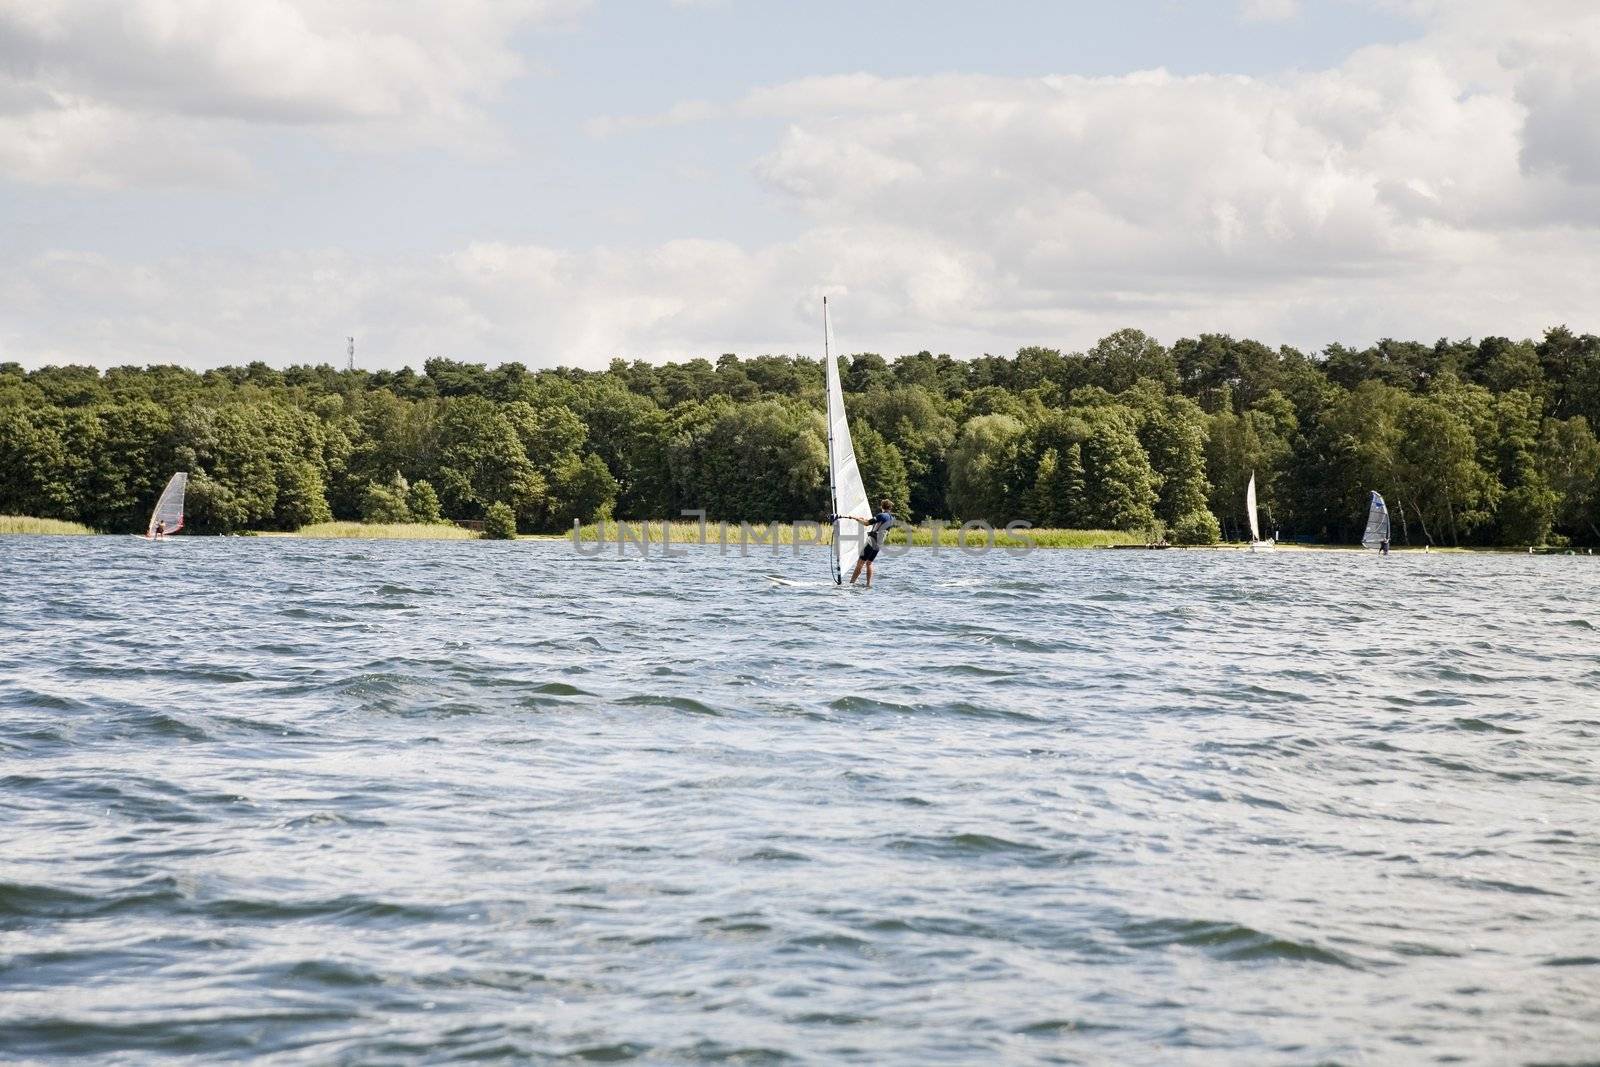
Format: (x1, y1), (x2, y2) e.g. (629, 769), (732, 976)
(0, 227), (994, 366)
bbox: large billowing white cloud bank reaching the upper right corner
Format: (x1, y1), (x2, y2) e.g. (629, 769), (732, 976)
(720, 0), (1600, 344)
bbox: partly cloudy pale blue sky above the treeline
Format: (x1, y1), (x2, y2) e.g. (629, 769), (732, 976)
(0, 0), (1600, 375)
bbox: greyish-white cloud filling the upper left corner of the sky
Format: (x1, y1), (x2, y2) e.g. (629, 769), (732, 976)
(0, 0), (582, 187)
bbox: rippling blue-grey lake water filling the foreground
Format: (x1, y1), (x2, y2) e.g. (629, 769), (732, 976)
(0, 537), (1600, 1064)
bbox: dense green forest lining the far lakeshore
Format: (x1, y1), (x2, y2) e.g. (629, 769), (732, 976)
(0, 326), (1600, 545)
